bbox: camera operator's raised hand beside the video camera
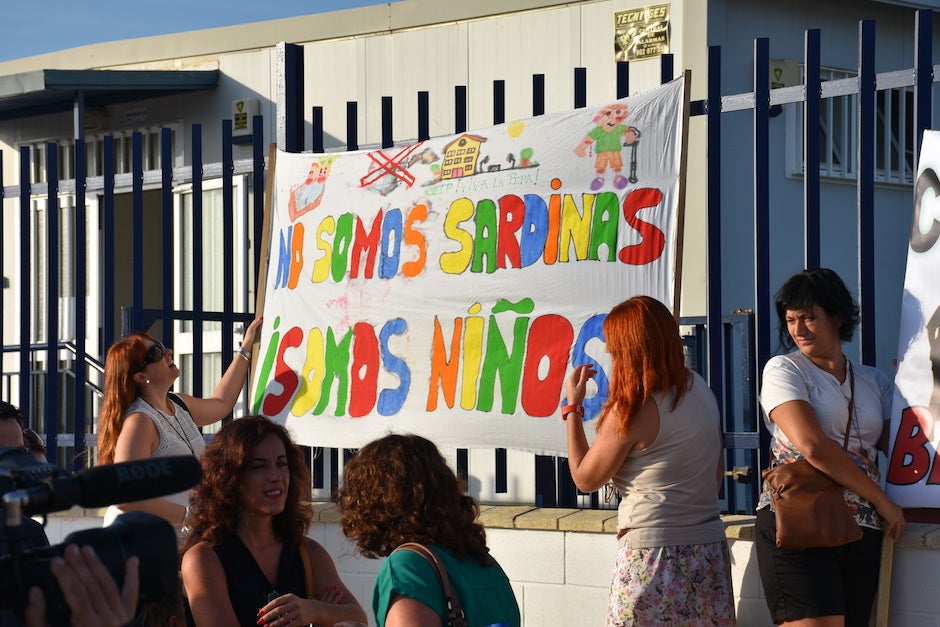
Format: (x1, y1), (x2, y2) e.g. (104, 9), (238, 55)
(25, 544), (140, 627)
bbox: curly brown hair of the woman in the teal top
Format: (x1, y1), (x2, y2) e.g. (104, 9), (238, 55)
(336, 434), (493, 566)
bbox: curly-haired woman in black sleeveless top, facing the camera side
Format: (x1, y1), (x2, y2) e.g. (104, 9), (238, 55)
(182, 416), (366, 627)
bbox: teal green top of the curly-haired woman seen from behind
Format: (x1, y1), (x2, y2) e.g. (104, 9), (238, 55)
(372, 547), (521, 627)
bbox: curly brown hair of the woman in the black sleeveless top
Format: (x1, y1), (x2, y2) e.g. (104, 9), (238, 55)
(182, 416), (313, 553)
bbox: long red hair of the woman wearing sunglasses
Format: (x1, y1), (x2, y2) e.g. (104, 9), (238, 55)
(98, 333), (153, 464)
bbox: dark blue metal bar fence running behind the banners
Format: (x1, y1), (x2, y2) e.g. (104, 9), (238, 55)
(0, 11), (935, 513)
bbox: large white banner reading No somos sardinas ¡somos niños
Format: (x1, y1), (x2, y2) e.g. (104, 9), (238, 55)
(252, 78), (687, 454)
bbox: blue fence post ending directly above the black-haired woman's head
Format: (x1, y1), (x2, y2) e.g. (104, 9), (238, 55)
(803, 29), (821, 268)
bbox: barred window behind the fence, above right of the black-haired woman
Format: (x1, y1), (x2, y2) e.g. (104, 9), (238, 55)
(787, 67), (914, 185)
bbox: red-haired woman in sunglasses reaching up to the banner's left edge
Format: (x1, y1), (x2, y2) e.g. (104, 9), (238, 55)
(98, 318), (261, 528)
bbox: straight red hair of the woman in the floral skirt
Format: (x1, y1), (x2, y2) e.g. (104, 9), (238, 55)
(597, 296), (689, 435)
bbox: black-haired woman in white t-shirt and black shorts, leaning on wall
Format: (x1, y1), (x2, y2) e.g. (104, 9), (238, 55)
(756, 268), (904, 627)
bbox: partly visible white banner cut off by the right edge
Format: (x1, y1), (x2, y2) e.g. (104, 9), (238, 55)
(887, 131), (940, 508)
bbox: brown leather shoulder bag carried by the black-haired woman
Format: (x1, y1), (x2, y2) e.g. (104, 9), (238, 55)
(762, 364), (862, 549)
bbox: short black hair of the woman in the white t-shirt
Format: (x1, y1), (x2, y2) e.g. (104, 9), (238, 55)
(774, 268), (859, 349)
